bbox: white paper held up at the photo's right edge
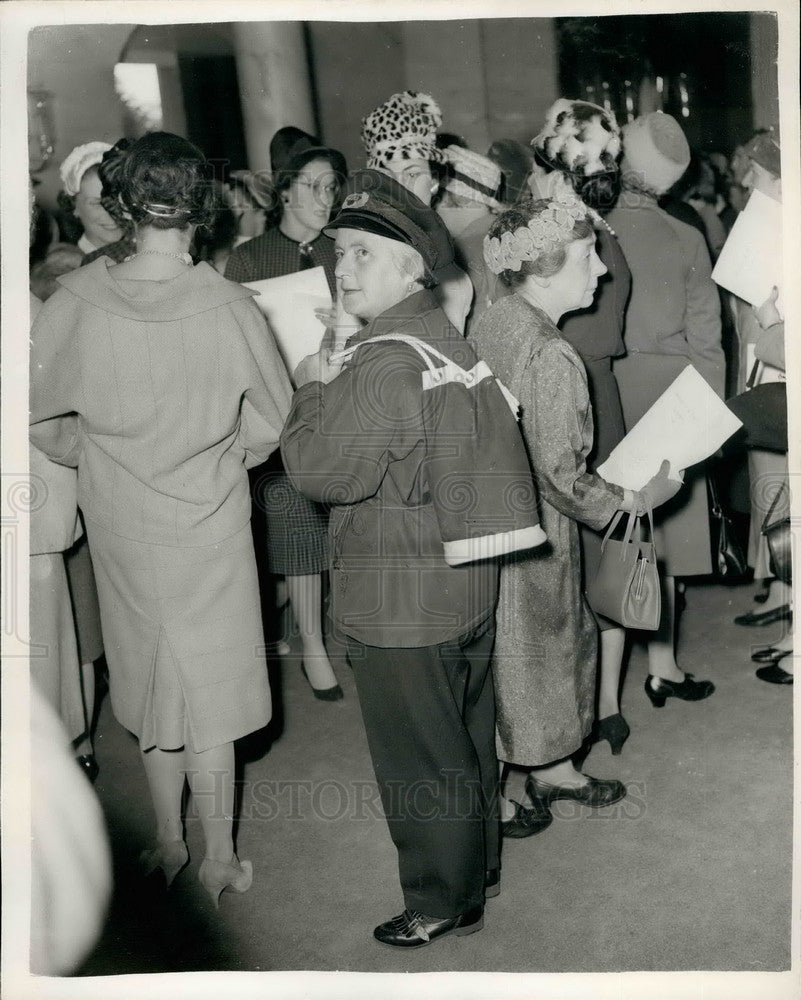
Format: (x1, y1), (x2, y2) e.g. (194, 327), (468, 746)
(712, 184), (784, 316)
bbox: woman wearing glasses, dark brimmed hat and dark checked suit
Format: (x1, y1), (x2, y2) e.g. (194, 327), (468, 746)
(225, 126), (347, 701)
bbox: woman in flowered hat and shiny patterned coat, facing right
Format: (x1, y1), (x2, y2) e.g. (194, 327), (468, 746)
(469, 191), (678, 837)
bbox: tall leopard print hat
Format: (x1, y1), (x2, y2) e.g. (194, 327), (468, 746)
(362, 90), (445, 170)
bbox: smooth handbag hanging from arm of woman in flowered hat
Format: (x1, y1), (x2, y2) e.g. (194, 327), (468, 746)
(587, 510), (662, 630)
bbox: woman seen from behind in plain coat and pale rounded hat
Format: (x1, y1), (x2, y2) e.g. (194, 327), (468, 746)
(607, 112), (726, 706)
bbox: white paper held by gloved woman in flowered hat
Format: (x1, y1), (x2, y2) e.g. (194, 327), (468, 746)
(598, 365), (742, 490)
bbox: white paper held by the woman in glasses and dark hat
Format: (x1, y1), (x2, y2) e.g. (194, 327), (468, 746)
(242, 267), (333, 376)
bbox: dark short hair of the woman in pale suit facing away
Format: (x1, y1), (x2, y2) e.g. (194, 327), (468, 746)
(119, 132), (218, 229)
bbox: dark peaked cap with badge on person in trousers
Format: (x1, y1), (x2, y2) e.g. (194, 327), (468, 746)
(323, 170), (453, 271)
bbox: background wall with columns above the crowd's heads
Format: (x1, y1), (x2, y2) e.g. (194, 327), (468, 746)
(28, 8), (778, 204)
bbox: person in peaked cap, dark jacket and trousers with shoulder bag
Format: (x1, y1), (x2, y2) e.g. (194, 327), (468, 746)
(281, 170), (544, 948)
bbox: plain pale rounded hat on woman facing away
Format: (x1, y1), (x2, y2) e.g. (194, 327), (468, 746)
(620, 111), (690, 194)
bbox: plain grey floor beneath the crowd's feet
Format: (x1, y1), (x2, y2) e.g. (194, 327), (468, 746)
(76, 582), (793, 997)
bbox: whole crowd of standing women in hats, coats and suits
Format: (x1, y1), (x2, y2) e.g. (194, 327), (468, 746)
(31, 91), (792, 964)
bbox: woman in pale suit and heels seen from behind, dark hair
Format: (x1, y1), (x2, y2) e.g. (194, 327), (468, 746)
(30, 132), (291, 905)
